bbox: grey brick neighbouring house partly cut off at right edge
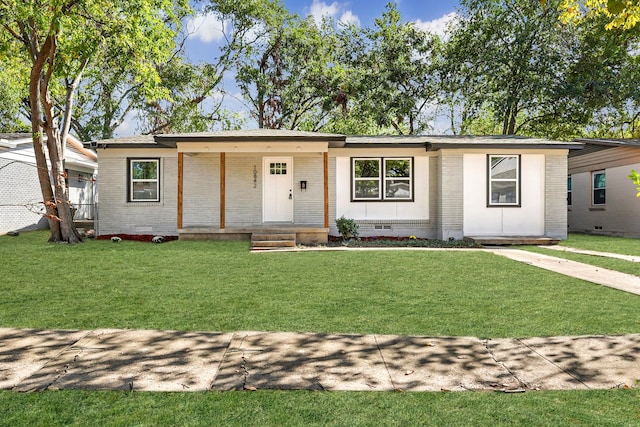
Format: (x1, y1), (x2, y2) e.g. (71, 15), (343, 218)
(567, 139), (640, 237)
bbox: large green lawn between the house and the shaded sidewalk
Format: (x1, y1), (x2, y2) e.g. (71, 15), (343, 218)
(0, 233), (640, 338)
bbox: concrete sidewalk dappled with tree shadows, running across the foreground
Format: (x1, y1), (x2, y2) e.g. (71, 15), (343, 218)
(0, 328), (640, 392)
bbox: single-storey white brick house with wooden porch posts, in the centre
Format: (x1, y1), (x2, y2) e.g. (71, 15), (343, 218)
(86, 130), (581, 243)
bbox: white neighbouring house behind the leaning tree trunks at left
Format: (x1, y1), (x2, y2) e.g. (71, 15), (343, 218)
(0, 133), (98, 234)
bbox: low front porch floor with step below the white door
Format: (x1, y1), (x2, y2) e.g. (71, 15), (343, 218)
(178, 224), (329, 245)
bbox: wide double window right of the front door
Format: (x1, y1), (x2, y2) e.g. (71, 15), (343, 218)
(352, 157), (413, 201)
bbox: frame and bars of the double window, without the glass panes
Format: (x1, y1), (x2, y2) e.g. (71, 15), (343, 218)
(351, 157), (414, 202)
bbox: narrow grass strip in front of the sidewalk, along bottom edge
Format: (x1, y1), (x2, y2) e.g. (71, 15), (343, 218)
(0, 389), (640, 427)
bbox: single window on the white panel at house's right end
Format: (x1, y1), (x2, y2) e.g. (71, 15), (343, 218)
(488, 155), (520, 206)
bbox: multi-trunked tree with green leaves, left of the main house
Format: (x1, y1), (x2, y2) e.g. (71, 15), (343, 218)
(0, 0), (188, 243)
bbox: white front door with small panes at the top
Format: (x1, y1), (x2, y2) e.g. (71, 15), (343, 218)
(262, 157), (293, 222)
